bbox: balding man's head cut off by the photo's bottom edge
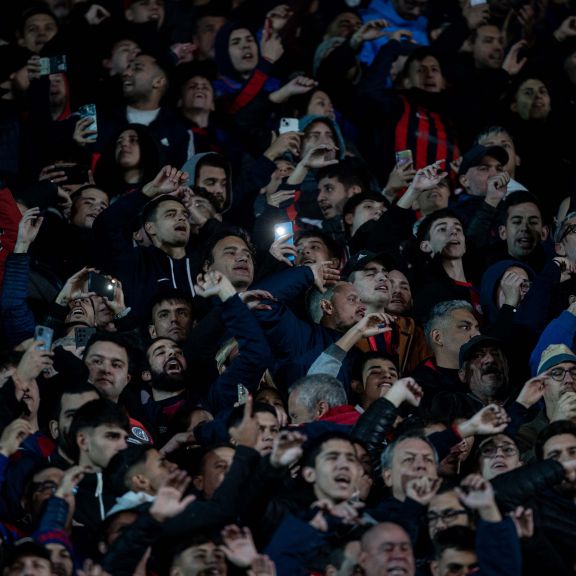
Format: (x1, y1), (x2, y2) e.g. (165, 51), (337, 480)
(358, 523), (416, 576)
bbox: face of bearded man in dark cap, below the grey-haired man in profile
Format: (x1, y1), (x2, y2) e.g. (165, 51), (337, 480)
(465, 345), (507, 398)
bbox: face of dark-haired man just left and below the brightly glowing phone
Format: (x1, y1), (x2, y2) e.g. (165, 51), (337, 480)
(207, 236), (254, 291)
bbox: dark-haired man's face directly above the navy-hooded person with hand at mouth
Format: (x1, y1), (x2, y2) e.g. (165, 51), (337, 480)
(499, 202), (546, 258)
